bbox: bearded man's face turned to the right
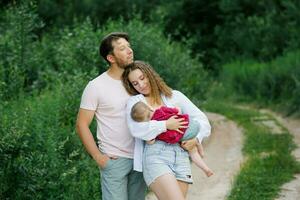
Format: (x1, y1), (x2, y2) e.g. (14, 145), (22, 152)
(112, 38), (133, 68)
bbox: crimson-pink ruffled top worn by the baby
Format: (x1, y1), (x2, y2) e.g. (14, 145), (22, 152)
(151, 106), (189, 144)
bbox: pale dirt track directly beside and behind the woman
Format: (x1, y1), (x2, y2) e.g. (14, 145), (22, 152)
(146, 113), (243, 200)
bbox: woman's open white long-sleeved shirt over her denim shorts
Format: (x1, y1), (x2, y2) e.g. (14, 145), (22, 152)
(126, 90), (211, 172)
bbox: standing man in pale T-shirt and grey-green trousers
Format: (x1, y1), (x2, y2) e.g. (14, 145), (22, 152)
(76, 33), (146, 200)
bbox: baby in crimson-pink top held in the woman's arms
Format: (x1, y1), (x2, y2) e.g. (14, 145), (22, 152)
(131, 101), (213, 177)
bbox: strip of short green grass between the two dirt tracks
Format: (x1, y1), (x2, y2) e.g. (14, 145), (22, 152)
(203, 100), (300, 200)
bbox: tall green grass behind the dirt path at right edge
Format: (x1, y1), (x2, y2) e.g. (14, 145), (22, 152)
(221, 51), (300, 114)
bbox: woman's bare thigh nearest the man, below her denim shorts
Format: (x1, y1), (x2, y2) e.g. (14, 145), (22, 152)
(150, 174), (185, 200)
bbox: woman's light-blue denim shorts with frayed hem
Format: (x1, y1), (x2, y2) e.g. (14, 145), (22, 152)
(143, 140), (193, 186)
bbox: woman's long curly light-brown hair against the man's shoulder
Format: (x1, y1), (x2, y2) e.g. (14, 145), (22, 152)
(122, 60), (172, 104)
